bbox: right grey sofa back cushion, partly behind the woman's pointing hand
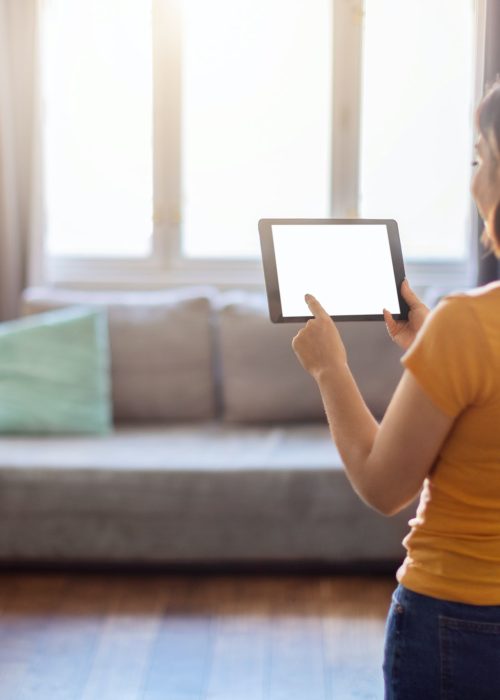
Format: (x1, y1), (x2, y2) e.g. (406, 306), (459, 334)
(217, 290), (403, 422)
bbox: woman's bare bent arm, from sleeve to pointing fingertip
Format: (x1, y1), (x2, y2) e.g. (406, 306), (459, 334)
(292, 297), (454, 515)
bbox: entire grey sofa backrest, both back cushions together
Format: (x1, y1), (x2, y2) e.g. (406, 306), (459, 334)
(23, 287), (403, 423)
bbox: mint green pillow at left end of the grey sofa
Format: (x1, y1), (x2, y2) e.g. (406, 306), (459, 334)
(0, 307), (112, 434)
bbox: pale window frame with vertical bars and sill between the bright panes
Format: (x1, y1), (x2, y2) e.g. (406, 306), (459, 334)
(45, 0), (487, 289)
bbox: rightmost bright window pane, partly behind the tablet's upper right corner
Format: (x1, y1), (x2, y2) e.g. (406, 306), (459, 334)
(359, 0), (475, 260)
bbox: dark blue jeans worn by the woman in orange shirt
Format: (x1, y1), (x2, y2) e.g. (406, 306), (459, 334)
(383, 584), (500, 700)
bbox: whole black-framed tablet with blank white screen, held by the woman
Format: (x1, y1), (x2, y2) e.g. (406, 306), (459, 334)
(259, 219), (408, 323)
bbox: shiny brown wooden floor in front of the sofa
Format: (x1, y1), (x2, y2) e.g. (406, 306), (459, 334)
(0, 573), (396, 700)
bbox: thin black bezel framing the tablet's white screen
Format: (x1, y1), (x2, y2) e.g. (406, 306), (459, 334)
(259, 219), (409, 323)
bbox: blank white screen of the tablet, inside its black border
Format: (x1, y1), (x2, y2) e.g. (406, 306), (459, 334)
(272, 224), (401, 316)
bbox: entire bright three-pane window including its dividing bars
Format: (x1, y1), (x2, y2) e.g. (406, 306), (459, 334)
(41, 0), (484, 284)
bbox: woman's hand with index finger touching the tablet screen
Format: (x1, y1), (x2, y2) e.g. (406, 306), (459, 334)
(292, 294), (347, 380)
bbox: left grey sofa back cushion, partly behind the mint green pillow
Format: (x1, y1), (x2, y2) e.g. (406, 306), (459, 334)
(23, 287), (215, 422)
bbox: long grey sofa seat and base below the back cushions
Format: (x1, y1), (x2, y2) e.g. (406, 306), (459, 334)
(0, 421), (415, 563)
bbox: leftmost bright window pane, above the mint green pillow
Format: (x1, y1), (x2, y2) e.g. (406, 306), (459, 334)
(42, 0), (153, 258)
